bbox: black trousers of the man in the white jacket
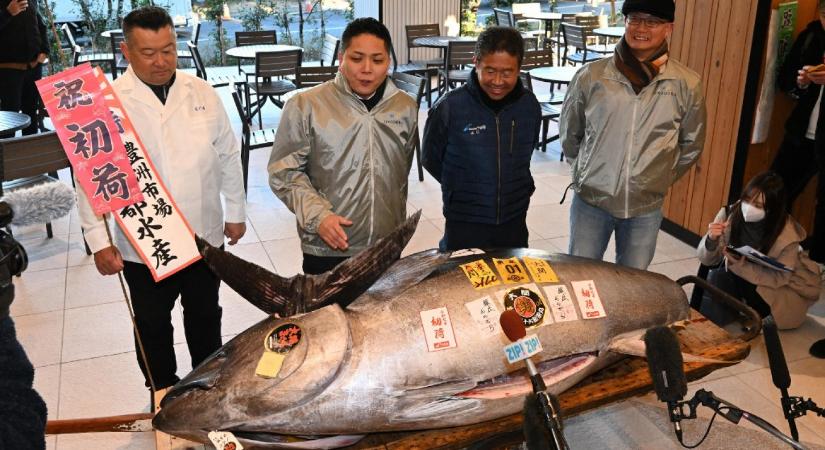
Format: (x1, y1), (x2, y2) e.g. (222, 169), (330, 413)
(123, 261), (222, 389)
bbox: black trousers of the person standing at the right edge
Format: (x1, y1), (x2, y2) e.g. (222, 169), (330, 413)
(771, 134), (825, 263)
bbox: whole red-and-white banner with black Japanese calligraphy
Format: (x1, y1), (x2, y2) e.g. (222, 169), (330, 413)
(38, 64), (200, 281)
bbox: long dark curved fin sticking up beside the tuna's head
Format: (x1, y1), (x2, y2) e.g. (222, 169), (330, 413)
(196, 211), (421, 317)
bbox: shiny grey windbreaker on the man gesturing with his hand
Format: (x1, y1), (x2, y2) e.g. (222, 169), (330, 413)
(267, 73), (418, 256)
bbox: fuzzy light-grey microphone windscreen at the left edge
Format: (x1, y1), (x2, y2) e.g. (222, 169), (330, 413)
(2, 181), (75, 226)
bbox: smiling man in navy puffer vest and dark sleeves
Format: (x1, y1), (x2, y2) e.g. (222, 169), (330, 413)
(422, 27), (541, 251)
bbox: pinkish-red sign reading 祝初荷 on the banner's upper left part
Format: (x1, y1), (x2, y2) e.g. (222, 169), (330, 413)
(37, 64), (143, 215)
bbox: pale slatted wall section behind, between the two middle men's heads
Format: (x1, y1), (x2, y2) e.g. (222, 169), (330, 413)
(381, 0), (461, 63)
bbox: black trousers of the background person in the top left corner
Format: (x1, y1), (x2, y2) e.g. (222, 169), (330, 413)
(0, 64), (43, 138)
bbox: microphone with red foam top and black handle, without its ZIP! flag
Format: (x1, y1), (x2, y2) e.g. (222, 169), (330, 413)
(499, 309), (570, 450)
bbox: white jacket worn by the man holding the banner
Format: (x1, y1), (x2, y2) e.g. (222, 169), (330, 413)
(77, 67), (246, 262)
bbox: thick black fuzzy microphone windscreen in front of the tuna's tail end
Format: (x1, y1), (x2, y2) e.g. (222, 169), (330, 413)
(644, 327), (687, 402)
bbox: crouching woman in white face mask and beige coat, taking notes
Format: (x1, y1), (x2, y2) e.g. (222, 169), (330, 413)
(698, 172), (820, 329)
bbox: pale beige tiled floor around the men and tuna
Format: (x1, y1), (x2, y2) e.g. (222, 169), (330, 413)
(12, 71), (825, 450)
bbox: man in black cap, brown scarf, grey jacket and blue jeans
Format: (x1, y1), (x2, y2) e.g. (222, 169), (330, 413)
(559, 0), (705, 269)
